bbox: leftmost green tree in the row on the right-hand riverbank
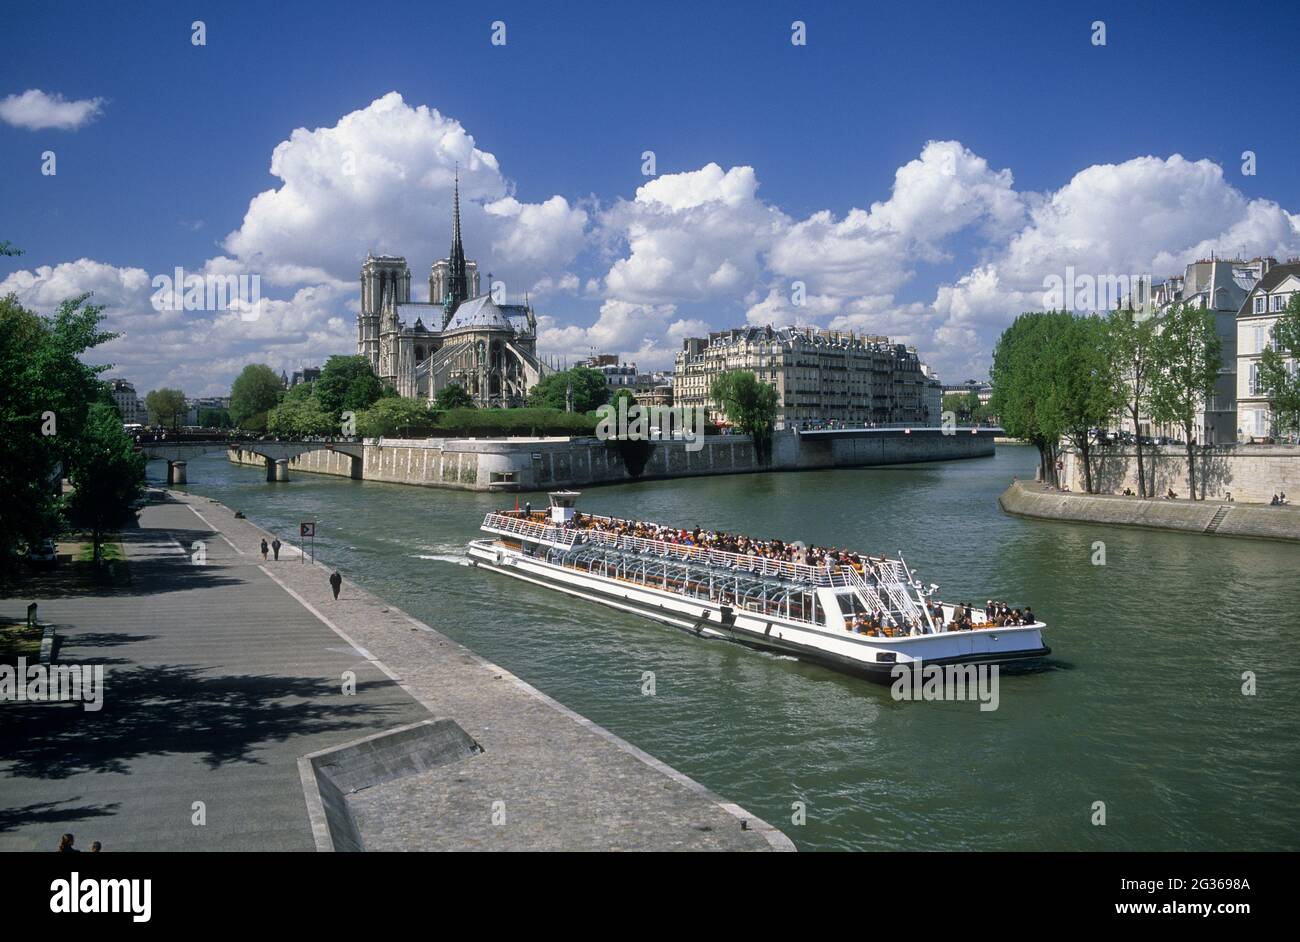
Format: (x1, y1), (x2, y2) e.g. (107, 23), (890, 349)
(989, 311), (1073, 485)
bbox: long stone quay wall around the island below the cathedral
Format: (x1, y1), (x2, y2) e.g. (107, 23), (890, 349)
(230, 429), (993, 491)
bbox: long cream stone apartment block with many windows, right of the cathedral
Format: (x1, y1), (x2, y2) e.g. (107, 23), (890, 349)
(672, 326), (941, 426)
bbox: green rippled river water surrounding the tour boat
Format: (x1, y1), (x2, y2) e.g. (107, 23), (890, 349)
(159, 447), (1300, 851)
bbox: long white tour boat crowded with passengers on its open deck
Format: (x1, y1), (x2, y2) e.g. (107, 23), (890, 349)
(468, 491), (1050, 682)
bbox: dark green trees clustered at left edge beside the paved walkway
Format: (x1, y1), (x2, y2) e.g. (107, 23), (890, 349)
(0, 289), (144, 570)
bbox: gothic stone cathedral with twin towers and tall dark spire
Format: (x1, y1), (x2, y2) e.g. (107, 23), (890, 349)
(356, 179), (551, 407)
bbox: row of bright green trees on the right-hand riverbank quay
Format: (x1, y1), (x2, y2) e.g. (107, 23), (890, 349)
(991, 304), (1222, 499)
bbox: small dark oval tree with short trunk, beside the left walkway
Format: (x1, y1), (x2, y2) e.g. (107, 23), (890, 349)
(68, 403), (146, 565)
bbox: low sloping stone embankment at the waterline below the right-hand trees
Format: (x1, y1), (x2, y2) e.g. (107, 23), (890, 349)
(997, 481), (1300, 542)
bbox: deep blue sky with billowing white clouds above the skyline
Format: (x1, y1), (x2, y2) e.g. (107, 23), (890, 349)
(0, 1), (1300, 394)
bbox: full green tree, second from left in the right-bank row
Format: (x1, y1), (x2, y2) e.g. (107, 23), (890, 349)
(1043, 314), (1119, 494)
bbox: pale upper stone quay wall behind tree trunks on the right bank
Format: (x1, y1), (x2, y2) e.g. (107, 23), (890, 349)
(1062, 444), (1300, 504)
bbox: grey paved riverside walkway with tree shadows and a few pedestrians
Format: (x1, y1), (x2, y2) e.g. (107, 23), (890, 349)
(0, 492), (793, 851)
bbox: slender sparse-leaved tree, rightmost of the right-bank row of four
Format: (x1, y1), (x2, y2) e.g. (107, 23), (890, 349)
(1151, 304), (1223, 500)
